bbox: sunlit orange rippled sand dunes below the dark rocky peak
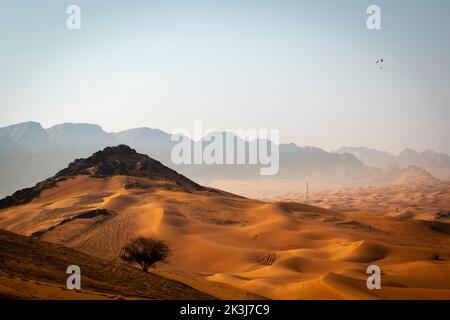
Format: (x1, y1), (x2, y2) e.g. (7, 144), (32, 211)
(0, 172), (450, 299)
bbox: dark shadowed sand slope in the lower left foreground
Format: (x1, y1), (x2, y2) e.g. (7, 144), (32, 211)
(0, 231), (217, 300)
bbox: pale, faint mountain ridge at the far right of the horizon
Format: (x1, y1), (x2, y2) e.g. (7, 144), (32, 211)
(337, 147), (450, 180)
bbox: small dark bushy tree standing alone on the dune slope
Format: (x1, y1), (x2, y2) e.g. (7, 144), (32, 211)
(120, 237), (170, 272)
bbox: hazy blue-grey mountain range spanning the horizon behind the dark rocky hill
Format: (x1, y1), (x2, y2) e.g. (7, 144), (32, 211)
(0, 122), (450, 196)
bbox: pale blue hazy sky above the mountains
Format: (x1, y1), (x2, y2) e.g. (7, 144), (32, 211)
(0, 0), (450, 153)
